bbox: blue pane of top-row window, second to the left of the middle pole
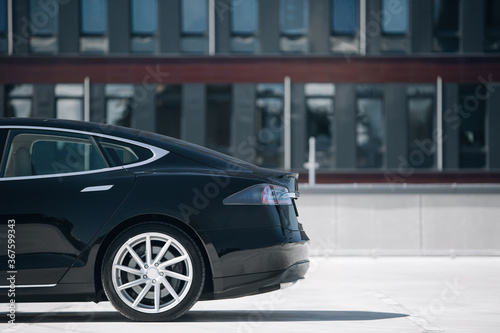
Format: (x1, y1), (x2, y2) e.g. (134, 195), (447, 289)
(130, 0), (158, 35)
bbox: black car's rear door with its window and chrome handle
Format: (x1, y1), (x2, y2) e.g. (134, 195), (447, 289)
(0, 129), (135, 287)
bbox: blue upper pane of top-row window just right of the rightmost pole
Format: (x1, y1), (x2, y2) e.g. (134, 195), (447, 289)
(382, 0), (408, 34)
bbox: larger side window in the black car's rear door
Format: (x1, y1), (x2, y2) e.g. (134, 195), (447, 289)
(3, 131), (107, 177)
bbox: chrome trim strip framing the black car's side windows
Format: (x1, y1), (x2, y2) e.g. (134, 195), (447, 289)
(0, 125), (170, 182)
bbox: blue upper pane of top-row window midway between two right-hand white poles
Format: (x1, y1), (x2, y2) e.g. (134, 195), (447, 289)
(280, 0), (309, 36)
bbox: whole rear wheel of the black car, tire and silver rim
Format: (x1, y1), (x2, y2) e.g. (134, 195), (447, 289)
(101, 222), (205, 321)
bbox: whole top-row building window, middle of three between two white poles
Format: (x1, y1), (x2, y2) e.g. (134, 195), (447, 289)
(280, 0), (309, 53)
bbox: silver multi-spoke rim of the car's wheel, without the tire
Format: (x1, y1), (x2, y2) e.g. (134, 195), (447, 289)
(112, 232), (193, 313)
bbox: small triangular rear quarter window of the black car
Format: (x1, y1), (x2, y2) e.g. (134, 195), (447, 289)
(96, 138), (153, 167)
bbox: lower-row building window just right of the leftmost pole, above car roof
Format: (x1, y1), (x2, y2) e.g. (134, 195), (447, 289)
(104, 84), (134, 127)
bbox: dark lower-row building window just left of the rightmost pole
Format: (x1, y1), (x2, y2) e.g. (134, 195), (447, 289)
(406, 84), (436, 168)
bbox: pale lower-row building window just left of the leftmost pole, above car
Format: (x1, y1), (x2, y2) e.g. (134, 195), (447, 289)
(55, 84), (83, 120)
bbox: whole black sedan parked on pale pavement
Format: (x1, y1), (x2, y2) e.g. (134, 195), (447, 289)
(0, 118), (309, 321)
